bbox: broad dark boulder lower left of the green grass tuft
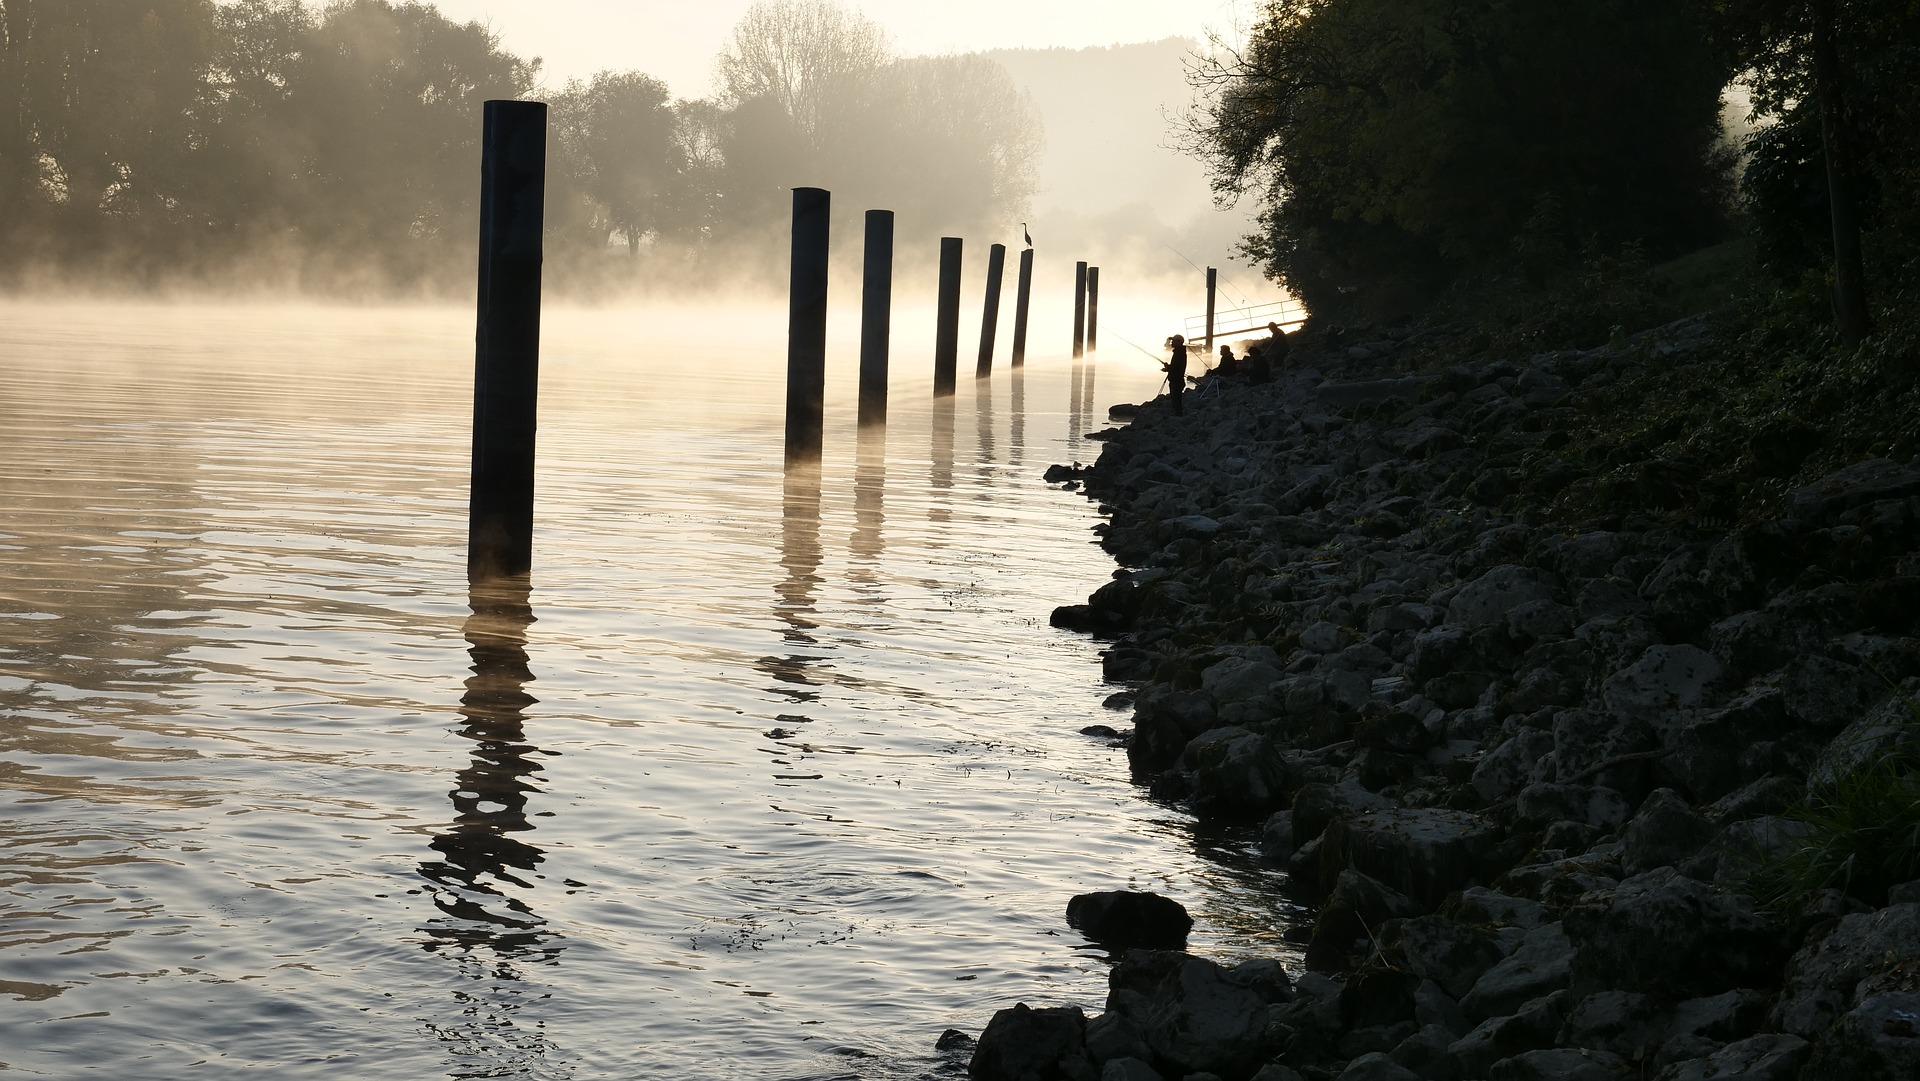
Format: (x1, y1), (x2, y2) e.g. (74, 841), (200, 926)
(1565, 868), (1786, 997)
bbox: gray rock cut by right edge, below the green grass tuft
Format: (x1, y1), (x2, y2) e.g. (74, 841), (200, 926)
(1770, 902), (1920, 1037)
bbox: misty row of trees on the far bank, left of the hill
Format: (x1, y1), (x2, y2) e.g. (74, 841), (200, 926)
(0, 0), (1041, 288)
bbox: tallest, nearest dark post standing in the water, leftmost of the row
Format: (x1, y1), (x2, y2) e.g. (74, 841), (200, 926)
(467, 102), (547, 582)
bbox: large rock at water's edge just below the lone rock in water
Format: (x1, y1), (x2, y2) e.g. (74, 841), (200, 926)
(1106, 950), (1275, 1077)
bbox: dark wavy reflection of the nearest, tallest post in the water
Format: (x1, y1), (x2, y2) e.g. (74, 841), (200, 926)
(420, 574), (559, 960)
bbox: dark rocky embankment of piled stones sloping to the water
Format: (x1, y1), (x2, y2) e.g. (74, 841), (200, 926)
(952, 319), (1920, 1081)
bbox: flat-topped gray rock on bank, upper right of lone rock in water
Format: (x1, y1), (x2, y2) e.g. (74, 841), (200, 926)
(1321, 806), (1500, 910)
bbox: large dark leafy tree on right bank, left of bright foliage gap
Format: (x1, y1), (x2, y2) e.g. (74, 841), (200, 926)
(1185, 0), (1728, 317)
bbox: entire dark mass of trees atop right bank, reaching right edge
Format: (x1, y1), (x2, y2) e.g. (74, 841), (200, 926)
(1187, 0), (1920, 330)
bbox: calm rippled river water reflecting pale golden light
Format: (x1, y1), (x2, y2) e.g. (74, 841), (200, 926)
(0, 303), (1279, 1079)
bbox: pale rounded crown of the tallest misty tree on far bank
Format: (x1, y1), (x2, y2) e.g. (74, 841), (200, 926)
(714, 0), (891, 148)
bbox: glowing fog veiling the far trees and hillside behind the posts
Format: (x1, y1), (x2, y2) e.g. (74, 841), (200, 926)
(0, 0), (1279, 326)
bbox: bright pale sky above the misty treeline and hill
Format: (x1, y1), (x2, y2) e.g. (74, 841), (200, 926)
(432, 0), (1260, 98)
